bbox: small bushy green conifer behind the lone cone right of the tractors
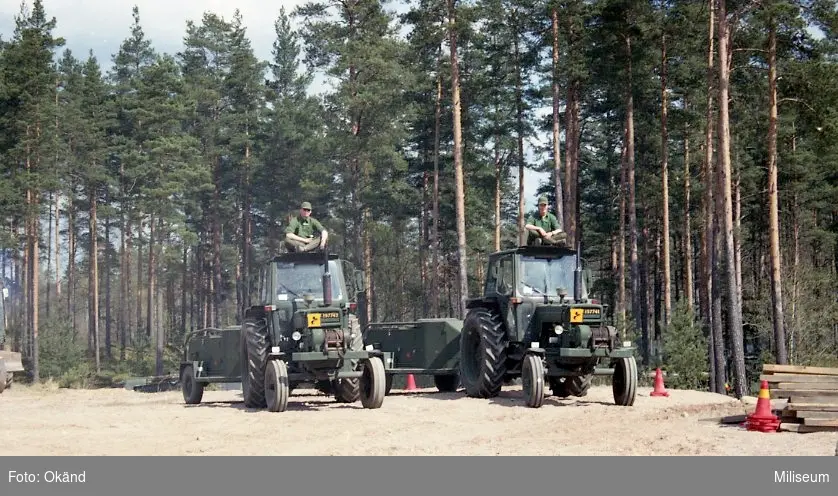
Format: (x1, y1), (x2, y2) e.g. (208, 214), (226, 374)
(663, 301), (707, 389)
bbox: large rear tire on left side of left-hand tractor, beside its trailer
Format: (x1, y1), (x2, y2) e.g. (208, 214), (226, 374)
(241, 319), (268, 408)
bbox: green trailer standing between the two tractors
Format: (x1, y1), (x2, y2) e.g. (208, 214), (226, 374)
(364, 318), (463, 394)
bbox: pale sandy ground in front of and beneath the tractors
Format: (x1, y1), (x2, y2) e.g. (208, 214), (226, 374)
(0, 385), (838, 456)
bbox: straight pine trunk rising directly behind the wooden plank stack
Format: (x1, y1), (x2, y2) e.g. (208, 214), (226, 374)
(768, 18), (788, 364)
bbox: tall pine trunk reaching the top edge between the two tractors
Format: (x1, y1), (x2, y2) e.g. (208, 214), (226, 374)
(448, 0), (468, 318)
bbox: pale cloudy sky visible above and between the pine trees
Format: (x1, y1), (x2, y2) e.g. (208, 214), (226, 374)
(0, 0), (549, 210)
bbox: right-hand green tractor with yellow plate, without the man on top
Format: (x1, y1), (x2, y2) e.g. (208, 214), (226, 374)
(460, 245), (637, 408)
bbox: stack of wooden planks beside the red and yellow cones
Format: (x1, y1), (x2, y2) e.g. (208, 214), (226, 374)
(760, 364), (838, 433)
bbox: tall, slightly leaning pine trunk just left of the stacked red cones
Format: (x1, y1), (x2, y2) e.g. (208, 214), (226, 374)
(717, 0), (748, 398)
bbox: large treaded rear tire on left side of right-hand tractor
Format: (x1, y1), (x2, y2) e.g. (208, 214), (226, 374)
(460, 308), (506, 398)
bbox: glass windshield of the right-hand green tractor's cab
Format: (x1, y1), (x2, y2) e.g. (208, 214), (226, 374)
(518, 256), (588, 298)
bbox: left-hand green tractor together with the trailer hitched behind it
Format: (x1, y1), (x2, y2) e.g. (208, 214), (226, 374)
(180, 252), (386, 412)
